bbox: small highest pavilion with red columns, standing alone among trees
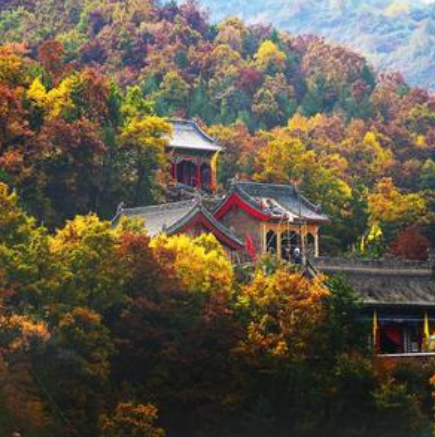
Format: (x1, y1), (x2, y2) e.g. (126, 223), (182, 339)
(168, 119), (223, 191)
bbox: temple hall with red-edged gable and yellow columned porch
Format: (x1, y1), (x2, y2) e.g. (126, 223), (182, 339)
(214, 181), (330, 261)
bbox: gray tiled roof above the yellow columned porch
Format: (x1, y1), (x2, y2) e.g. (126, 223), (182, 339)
(233, 181), (329, 223)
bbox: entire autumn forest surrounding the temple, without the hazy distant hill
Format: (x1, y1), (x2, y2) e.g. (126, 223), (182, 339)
(0, 0), (435, 437)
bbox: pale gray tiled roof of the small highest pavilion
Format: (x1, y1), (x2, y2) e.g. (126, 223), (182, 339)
(169, 119), (222, 152)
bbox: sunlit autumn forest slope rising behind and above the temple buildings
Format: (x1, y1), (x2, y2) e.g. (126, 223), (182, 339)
(0, 0), (435, 256)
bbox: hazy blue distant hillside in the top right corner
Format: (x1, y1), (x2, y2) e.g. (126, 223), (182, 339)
(190, 0), (435, 91)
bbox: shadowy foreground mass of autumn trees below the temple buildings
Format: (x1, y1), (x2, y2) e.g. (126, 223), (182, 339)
(0, 184), (433, 437)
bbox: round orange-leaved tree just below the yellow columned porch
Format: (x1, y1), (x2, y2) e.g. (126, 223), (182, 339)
(237, 267), (329, 366)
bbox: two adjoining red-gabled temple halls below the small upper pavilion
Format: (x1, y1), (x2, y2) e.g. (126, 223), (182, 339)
(113, 181), (329, 261)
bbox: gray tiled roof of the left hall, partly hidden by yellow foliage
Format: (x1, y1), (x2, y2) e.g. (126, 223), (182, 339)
(114, 199), (244, 249)
